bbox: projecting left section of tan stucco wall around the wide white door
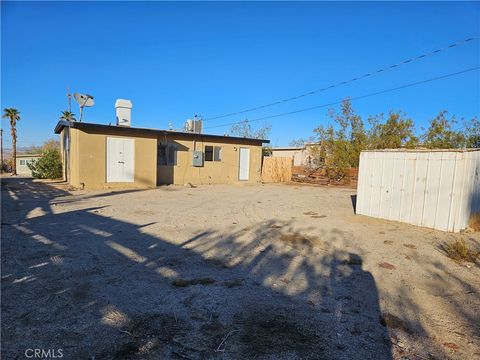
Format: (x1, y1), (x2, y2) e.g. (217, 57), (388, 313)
(70, 129), (157, 189)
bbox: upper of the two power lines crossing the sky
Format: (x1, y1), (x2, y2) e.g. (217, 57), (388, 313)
(204, 37), (478, 121)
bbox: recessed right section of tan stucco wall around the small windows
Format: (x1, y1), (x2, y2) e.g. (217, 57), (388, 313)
(157, 136), (262, 185)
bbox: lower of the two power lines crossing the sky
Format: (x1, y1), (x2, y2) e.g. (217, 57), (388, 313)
(205, 66), (480, 129)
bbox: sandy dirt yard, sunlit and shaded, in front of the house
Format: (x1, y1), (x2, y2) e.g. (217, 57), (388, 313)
(1, 178), (480, 360)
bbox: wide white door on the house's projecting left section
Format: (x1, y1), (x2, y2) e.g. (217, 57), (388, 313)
(107, 137), (135, 182)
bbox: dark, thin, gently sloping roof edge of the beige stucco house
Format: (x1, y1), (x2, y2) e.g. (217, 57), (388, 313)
(54, 120), (270, 145)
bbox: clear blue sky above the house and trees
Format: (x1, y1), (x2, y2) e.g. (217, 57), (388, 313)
(1, 1), (480, 147)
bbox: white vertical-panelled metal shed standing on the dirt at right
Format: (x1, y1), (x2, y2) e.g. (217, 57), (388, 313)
(356, 149), (480, 232)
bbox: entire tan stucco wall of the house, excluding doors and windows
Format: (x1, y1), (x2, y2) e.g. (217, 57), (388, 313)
(62, 128), (262, 189)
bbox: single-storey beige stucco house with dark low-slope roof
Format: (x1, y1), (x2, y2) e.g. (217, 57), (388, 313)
(55, 121), (269, 189)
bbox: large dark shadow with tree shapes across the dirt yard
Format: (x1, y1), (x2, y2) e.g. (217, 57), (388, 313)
(2, 179), (460, 359)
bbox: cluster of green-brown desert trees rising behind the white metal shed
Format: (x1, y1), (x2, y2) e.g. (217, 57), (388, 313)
(306, 98), (480, 181)
